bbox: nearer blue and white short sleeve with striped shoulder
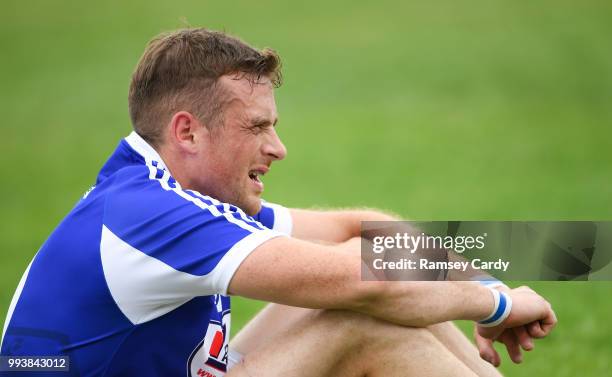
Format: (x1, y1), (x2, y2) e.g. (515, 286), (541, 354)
(100, 167), (282, 323)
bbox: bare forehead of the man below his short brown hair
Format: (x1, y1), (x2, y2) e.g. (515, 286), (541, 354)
(219, 74), (277, 121)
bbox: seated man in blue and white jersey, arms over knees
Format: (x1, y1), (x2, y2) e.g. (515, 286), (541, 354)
(2, 29), (556, 376)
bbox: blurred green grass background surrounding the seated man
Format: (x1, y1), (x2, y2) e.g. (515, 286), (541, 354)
(0, 0), (612, 376)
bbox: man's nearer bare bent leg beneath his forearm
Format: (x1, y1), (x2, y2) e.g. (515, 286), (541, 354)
(228, 310), (476, 377)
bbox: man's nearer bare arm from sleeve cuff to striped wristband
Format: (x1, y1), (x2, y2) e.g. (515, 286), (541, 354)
(229, 237), (542, 327)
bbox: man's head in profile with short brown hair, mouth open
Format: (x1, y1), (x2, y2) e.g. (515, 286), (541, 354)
(129, 29), (286, 214)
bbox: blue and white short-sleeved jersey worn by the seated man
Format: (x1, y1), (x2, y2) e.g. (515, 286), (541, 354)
(0, 133), (291, 377)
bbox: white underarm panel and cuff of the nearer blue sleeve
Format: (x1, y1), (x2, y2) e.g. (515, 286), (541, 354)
(100, 225), (281, 325)
